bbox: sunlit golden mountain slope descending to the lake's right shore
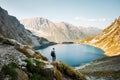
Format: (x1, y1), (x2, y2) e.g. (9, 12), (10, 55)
(77, 17), (120, 56)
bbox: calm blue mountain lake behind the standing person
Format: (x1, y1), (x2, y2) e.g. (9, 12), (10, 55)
(39, 44), (105, 66)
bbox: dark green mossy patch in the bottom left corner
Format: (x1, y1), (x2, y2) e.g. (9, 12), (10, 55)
(1, 63), (18, 80)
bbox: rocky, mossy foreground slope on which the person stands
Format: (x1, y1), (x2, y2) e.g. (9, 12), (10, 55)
(0, 36), (86, 80)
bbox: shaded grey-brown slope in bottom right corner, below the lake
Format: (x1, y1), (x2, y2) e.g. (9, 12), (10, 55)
(76, 56), (120, 80)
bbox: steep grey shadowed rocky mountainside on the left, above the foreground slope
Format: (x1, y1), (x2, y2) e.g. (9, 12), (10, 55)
(0, 7), (52, 46)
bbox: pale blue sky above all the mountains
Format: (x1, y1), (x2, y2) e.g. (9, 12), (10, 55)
(0, 0), (120, 29)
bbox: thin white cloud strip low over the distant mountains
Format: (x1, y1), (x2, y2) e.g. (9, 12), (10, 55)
(75, 17), (107, 22)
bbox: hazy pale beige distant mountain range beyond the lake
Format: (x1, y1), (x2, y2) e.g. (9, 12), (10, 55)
(20, 17), (101, 43)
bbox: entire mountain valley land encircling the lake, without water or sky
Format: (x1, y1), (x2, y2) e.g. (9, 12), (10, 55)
(0, 7), (120, 80)
